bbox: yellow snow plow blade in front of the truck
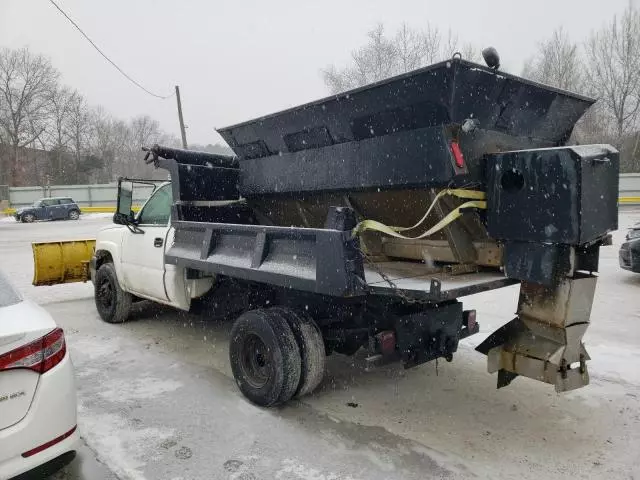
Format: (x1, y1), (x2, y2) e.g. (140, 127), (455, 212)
(31, 240), (96, 286)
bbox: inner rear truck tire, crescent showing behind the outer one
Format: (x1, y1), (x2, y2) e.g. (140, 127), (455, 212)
(273, 307), (327, 397)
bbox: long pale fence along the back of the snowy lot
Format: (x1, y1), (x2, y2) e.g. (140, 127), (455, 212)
(3, 173), (640, 208)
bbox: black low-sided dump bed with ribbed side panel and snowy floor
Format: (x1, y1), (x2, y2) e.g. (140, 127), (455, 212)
(165, 221), (516, 303)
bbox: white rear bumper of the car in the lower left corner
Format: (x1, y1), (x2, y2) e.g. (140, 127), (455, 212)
(0, 353), (80, 479)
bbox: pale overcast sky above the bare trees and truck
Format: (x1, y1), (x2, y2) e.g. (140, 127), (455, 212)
(0, 0), (628, 143)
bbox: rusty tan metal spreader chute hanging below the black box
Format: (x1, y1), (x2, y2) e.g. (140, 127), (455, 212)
(476, 275), (597, 392)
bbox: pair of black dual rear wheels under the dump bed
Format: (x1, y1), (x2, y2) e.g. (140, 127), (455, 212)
(229, 307), (325, 407)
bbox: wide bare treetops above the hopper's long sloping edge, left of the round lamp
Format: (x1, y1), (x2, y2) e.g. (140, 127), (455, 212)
(322, 24), (477, 93)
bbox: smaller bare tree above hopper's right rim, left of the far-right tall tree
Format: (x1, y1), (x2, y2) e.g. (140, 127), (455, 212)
(522, 28), (584, 91)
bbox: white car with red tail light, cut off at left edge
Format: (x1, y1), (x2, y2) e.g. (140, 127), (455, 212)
(0, 272), (80, 479)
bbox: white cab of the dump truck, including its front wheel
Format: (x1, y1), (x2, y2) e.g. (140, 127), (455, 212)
(90, 179), (213, 323)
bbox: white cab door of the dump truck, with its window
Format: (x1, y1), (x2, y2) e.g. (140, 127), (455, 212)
(120, 184), (172, 301)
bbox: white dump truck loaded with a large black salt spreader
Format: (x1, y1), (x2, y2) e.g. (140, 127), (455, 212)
(34, 53), (619, 406)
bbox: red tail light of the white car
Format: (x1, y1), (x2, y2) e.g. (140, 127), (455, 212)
(0, 328), (67, 373)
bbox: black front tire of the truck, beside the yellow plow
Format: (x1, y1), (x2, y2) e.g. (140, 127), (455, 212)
(94, 262), (133, 323)
